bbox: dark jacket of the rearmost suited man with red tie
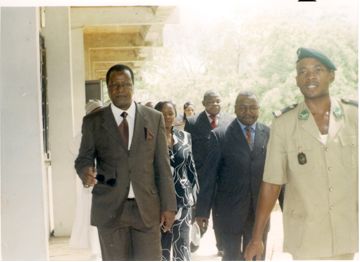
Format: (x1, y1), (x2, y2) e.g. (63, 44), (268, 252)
(184, 111), (234, 177)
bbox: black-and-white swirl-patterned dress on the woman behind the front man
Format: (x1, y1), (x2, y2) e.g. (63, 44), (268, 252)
(161, 129), (199, 261)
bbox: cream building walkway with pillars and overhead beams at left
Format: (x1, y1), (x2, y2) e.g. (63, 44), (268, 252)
(0, 5), (177, 260)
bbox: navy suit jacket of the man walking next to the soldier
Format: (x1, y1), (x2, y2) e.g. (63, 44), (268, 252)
(196, 119), (269, 233)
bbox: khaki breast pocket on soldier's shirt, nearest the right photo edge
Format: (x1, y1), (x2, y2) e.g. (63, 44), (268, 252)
(339, 135), (358, 167)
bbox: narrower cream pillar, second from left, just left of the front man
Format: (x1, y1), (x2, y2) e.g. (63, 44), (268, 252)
(43, 7), (75, 236)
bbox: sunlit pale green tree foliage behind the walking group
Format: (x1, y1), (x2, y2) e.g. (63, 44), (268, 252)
(136, 6), (358, 124)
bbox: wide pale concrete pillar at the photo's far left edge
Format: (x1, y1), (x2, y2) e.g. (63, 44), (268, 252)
(0, 7), (48, 260)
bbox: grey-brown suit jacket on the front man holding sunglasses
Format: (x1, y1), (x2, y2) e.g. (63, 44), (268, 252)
(75, 104), (176, 226)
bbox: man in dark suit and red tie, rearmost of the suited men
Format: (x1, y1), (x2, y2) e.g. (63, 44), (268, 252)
(184, 90), (233, 254)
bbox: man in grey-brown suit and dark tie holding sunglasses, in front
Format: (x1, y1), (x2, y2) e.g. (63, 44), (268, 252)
(75, 64), (176, 260)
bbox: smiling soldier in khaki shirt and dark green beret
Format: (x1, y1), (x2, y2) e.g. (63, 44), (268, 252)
(245, 48), (358, 260)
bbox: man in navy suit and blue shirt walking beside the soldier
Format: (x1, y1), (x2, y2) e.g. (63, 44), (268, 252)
(196, 92), (269, 260)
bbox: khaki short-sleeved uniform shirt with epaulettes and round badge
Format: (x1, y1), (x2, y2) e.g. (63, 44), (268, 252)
(263, 99), (358, 259)
